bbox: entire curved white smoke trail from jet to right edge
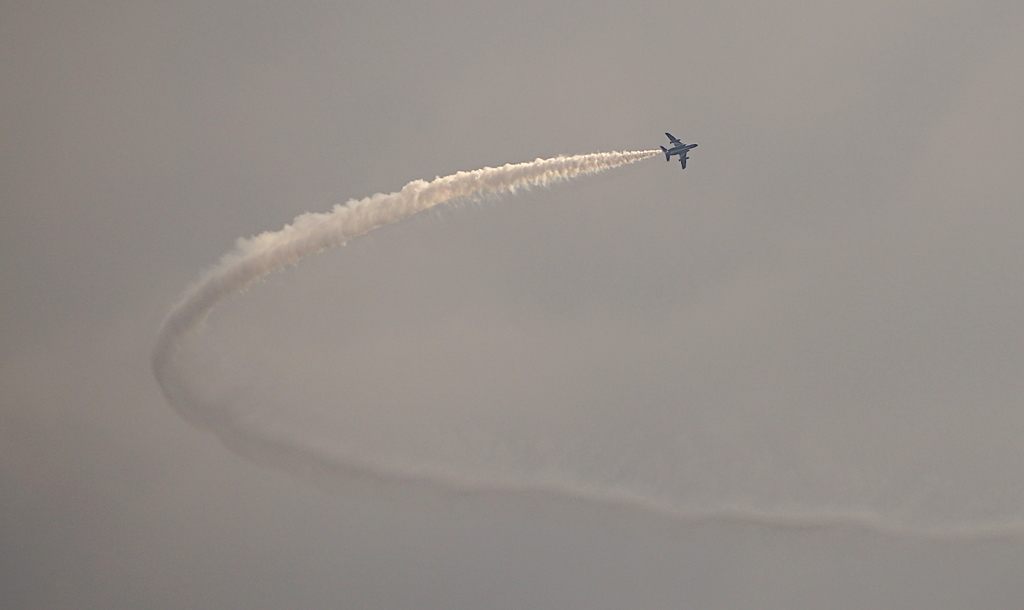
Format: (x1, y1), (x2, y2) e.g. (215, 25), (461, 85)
(153, 150), (1024, 539)
